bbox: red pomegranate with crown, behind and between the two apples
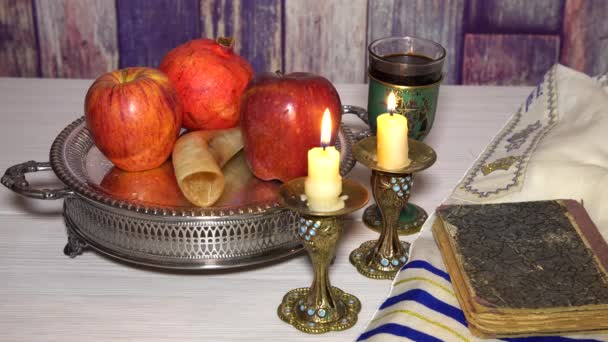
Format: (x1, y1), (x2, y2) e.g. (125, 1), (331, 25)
(159, 38), (253, 130)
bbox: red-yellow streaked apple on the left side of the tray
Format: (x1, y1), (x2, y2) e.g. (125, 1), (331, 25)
(84, 67), (182, 171)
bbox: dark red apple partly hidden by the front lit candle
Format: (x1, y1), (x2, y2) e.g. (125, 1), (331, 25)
(241, 72), (342, 182)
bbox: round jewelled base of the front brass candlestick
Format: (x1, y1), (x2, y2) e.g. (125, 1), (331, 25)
(277, 286), (361, 334)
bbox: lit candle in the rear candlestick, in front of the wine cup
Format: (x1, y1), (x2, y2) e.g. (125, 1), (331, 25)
(376, 92), (410, 170)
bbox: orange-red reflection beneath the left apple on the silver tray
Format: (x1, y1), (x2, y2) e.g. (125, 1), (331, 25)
(100, 160), (192, 207)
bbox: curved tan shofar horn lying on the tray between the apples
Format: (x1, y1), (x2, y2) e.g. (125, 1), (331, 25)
(173, 128), (243, 207)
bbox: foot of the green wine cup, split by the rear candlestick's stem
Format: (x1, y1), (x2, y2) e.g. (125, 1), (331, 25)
(363, 203), (429, 235)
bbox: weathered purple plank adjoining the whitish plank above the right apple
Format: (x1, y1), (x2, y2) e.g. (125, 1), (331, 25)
(201, 0), (283, 73)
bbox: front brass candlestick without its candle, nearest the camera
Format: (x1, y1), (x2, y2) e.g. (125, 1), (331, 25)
(278, 177), (369, 334)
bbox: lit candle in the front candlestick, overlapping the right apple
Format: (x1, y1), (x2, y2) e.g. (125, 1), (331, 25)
(304, 109), (344, 212)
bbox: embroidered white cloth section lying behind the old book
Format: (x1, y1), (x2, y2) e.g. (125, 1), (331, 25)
(450, 65), (608, 239)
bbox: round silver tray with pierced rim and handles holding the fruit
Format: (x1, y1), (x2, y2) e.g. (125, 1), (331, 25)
(2, 106), (365, 269)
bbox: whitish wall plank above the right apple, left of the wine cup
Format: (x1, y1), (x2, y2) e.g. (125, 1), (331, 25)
(285, 0), (367, 83)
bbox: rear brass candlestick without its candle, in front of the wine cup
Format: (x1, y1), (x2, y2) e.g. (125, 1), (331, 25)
(350, 137), (437, 279)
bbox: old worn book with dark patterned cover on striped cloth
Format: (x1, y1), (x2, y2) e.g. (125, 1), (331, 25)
(433, 200), (608, 337)
